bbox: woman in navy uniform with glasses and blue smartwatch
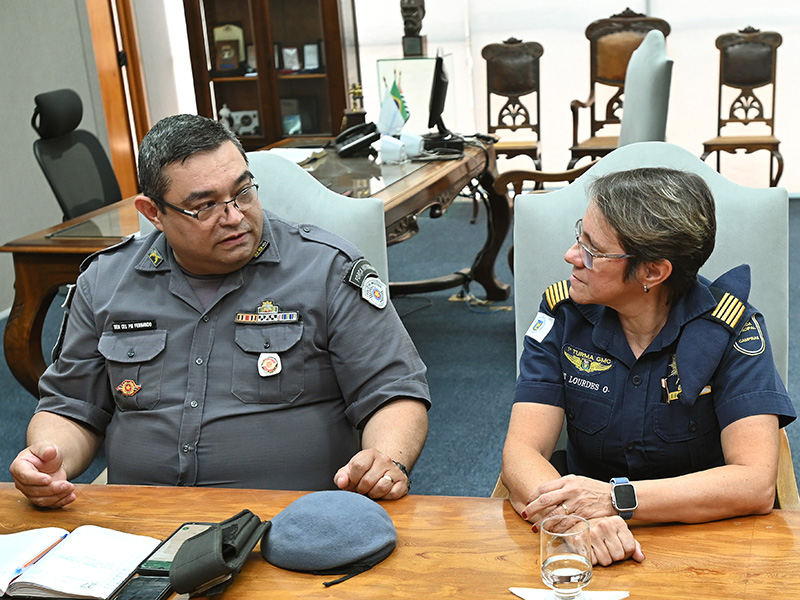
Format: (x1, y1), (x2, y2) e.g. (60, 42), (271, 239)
(502, 168), (796, 565)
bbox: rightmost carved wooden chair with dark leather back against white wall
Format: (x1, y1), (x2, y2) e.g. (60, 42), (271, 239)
(701, 27), (783, 187)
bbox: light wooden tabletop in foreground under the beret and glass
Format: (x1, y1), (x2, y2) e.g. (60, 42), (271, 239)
(0, 483), (800, 600)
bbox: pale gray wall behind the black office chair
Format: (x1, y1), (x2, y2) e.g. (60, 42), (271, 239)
(0, 0), (107, 311)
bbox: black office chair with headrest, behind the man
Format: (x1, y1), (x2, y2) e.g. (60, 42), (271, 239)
(31, 89), (122, 221)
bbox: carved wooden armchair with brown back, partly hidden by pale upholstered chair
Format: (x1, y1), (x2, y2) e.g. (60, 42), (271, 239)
(567, 9), (670, 169)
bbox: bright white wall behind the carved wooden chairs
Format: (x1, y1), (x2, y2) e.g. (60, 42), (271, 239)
(356, 0), (800, 192)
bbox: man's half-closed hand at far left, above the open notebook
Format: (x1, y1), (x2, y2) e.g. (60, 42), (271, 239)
(9, 444), (75, 508)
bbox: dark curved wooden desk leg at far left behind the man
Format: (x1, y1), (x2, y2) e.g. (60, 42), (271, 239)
(3, 253), (83, 398)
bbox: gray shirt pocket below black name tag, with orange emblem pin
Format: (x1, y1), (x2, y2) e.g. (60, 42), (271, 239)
(97, 330), (167, 411)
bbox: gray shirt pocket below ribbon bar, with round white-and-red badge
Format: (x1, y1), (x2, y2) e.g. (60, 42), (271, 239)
(231, 323), (305, 404)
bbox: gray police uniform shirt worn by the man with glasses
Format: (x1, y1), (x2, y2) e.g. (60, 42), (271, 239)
(37, 211), (430, 490)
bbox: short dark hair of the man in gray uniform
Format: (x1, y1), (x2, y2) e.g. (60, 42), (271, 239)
(139, 114), (248, 212)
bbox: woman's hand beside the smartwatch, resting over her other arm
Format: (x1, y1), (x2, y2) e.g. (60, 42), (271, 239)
(521, 475), (616, 525)
